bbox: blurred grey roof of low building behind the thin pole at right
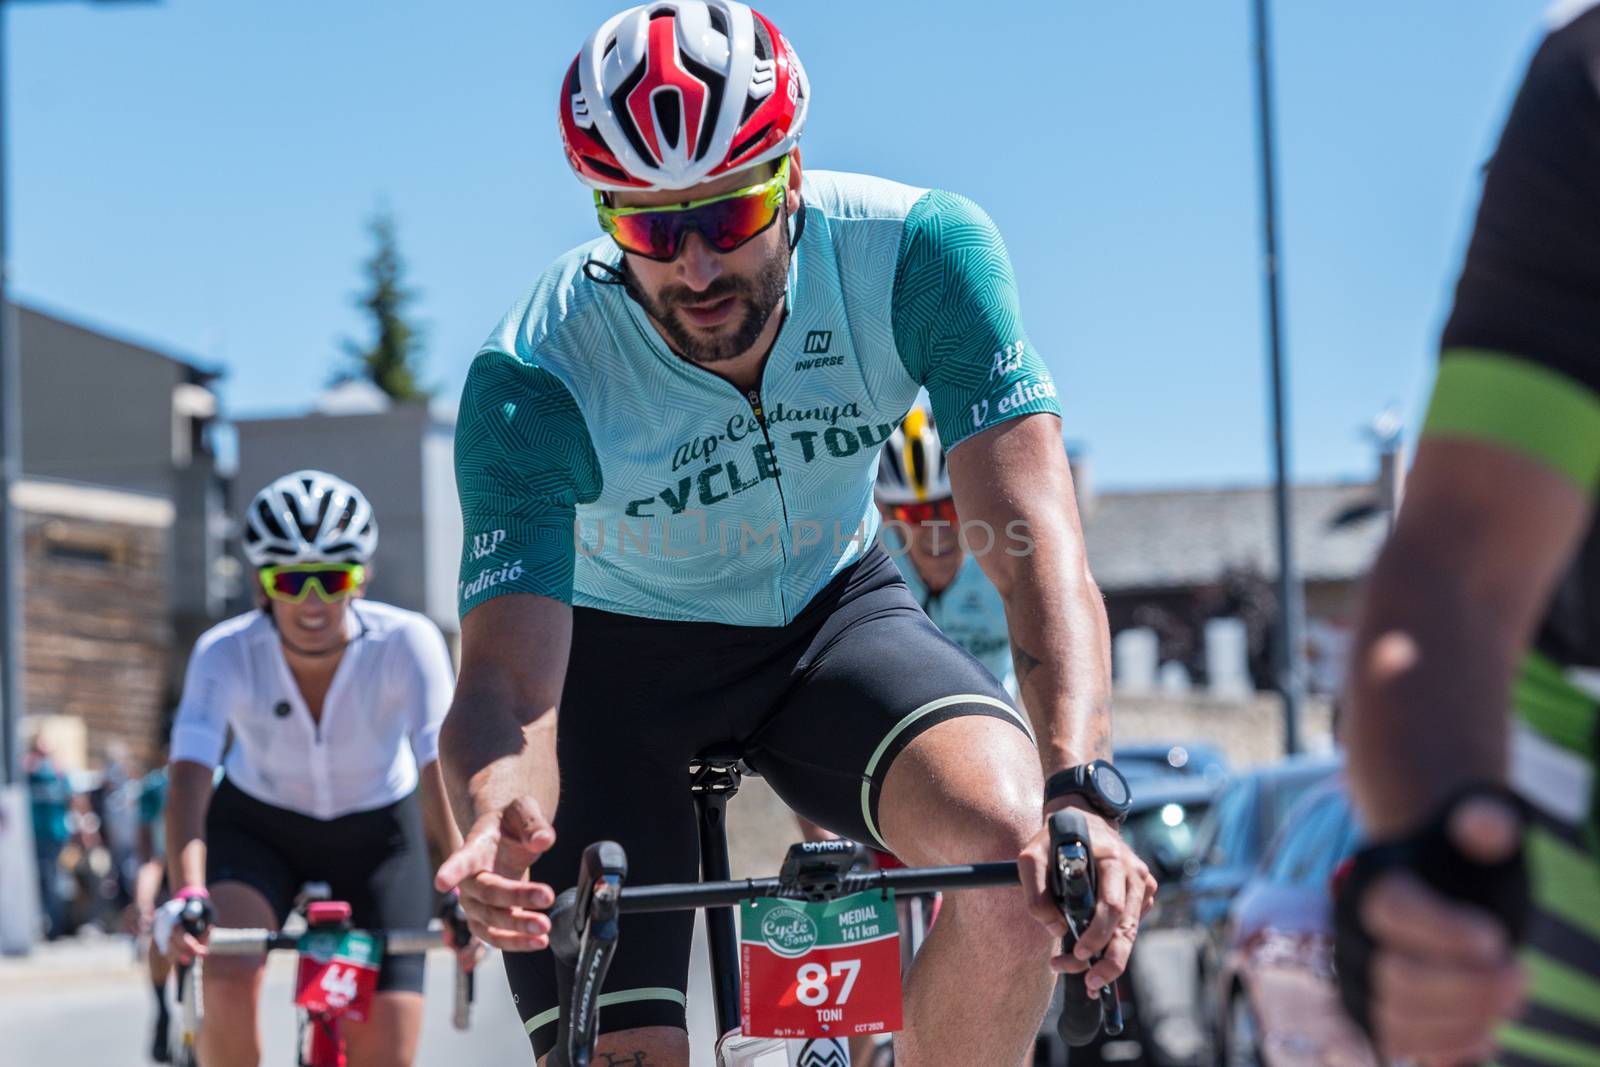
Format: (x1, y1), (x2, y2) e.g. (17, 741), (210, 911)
(1083, 482), (1387, 592)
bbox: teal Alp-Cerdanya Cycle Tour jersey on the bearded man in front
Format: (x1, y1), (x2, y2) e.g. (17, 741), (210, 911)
(456, 171), (1059, 627)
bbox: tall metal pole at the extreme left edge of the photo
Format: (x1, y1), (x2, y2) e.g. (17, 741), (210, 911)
(0, 0), (22, 784)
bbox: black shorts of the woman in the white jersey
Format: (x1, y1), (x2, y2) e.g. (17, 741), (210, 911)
(205, 777), (434, 993)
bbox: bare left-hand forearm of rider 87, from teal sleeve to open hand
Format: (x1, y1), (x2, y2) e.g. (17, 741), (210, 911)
(438, 593), (573, 830)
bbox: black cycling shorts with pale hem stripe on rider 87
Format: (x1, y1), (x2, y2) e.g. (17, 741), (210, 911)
(504, 549), (1029, 1056)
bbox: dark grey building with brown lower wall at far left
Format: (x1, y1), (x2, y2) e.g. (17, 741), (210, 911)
(13, 307), (234, 768)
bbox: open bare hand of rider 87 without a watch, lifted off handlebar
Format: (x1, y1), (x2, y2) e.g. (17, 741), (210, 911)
(434, 797), (555, 952)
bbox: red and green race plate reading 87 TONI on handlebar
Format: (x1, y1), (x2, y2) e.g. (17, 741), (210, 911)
(739, 889), (901, 1038)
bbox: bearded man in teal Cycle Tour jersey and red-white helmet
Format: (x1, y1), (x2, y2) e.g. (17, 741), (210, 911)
(437, 0), (1154, 1067)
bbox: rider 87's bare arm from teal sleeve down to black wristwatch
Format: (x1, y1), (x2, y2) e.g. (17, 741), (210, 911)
(949, 414), (1110, 774)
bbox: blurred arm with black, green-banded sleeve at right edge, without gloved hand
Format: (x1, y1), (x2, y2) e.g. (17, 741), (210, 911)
(1350, 13), (1600, 835)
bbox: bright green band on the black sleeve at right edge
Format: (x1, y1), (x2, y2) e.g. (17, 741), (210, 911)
(1422, 349), (1600, 493)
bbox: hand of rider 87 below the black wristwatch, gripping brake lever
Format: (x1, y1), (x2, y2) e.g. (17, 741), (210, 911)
(1018, 797), (1155, 995)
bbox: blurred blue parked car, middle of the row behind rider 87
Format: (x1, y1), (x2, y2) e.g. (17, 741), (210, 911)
(1155, 755), (1341, 1062)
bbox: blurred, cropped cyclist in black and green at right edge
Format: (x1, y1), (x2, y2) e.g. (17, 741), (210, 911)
(1338, 3), (1600, 1067)
